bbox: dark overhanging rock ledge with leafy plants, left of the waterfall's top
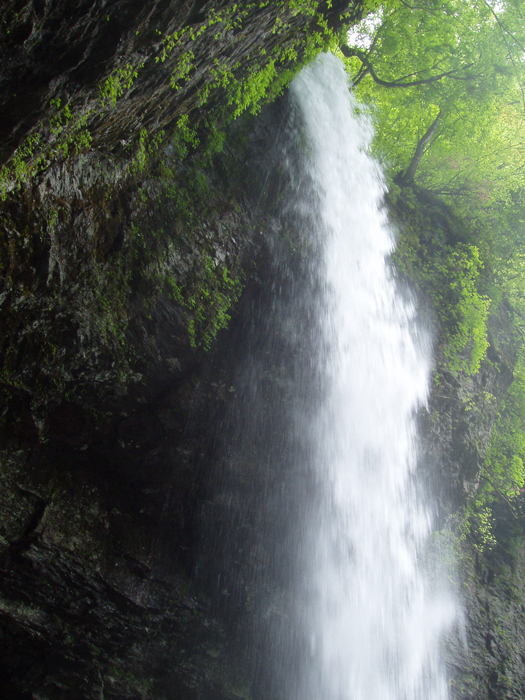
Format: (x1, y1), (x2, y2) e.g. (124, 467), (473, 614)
(0, 0), (359, 165)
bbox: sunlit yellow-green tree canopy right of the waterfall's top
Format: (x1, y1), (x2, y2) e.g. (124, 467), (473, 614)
(346, 0), (525, 205)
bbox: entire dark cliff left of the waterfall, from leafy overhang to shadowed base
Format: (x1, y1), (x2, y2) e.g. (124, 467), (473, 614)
(0, 0), (358, 700)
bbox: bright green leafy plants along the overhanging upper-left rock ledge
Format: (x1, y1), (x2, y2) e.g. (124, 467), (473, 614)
(0, 0), (336, 199)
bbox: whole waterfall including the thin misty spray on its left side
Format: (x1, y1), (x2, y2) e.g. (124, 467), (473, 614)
(197, 55), (457, 700)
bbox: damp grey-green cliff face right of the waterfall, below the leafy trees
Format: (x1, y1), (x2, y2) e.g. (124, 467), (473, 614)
(391, 188), (525, 700)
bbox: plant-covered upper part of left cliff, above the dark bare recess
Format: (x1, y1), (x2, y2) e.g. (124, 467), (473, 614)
(0, 2), (354, 410)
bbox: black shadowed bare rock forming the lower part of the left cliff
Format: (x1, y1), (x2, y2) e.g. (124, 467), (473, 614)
(0, 146), (260, 699)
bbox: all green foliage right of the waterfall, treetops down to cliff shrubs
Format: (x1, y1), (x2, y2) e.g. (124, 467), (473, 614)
(356, 0), (525, 540)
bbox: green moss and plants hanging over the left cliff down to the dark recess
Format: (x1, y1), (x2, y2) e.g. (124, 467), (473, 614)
(0, 0), (358, 416)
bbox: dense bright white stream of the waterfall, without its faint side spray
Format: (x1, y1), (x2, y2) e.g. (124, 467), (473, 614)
(291, 55), (456, 700)
